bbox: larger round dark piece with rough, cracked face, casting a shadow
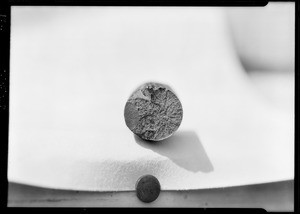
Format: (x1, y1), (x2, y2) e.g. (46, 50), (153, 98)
(124, 82), (183, 141)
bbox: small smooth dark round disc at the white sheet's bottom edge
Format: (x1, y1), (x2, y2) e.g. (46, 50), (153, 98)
(135, 175), (160, 203)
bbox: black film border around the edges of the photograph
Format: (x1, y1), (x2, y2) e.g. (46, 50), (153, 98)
(0, 0), (300, 213)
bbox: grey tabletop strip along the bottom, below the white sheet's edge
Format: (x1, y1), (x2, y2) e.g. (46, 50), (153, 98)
(8, 180), (294, 211)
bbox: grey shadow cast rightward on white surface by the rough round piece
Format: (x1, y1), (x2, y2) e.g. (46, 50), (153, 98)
(134, 131), (214, 173)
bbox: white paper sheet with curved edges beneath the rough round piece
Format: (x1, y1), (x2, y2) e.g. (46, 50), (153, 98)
(8, 7), (294, 191)
